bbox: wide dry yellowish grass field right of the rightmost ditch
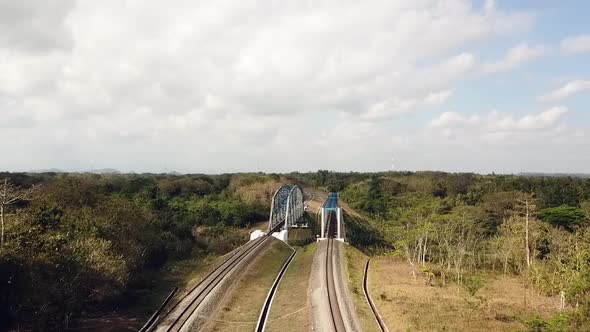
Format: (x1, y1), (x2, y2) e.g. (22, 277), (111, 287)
(369, 257), (558, 331)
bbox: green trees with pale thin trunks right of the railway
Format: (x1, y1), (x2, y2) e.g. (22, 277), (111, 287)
(331, 172), (590, 330)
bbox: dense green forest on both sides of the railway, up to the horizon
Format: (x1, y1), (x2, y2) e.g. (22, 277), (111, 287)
(0, 171), (590, 331)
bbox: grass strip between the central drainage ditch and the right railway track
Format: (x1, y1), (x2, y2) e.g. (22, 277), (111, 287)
(266, 242), (317, 332)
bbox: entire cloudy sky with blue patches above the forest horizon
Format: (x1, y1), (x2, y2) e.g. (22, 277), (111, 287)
(0, 0), (590, 173)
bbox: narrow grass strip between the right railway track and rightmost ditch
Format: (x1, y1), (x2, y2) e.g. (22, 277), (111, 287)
(344, 245), (380, 332)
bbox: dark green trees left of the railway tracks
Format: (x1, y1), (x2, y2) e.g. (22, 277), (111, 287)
(0, 173), (285, 330)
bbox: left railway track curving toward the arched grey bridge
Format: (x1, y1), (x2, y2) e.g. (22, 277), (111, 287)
(145, 225), (281, 332)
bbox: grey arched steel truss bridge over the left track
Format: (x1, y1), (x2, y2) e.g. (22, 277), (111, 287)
(268, 184), (304, 231)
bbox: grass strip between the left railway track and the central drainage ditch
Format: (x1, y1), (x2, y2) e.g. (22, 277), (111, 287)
(212, 239), (291, 331)
